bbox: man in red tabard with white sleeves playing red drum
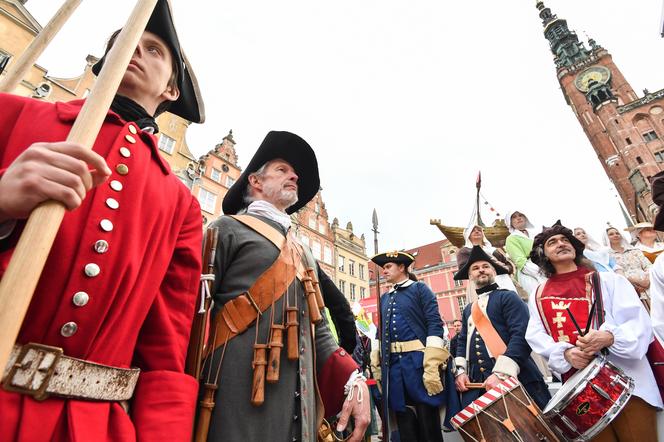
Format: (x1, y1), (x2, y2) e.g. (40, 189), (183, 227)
(526, 221), (662, 442)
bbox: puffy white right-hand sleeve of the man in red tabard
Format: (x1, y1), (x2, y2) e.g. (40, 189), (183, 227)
(599, 272), (653, 359)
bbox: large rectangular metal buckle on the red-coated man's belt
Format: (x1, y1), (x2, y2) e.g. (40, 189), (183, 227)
(2, 343), (62, 401)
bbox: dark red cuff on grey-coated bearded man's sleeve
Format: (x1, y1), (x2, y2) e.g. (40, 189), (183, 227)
(318, 348), (358, 417)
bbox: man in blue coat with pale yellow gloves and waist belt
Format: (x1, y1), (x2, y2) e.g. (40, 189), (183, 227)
(372, 252), (460, 442)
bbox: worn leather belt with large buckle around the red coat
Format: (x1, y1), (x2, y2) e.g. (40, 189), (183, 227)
(2, 343), (140, 401)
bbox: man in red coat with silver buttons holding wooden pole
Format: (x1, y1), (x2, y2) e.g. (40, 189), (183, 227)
(0, 0), (204, 441)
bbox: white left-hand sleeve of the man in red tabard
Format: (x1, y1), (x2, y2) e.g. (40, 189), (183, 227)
(526, 284), (573, 374)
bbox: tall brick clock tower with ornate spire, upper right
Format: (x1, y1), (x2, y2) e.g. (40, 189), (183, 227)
(536, 1), (664, 222)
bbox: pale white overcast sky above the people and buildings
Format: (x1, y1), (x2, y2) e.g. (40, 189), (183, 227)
(26, 0), (664, 250)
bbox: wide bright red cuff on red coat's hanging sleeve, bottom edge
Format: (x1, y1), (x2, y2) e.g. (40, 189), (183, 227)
(131, 370), (198, 442)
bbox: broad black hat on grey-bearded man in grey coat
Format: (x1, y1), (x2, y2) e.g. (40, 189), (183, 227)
(222, 131), (320, 215)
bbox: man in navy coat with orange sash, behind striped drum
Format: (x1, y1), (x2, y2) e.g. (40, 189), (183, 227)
(454, 246), (551, 409)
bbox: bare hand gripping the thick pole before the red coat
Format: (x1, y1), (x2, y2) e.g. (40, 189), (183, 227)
(0, 142), (111, 221)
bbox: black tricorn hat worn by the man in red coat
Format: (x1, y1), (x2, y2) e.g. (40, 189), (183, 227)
(92, 0), (205, 123)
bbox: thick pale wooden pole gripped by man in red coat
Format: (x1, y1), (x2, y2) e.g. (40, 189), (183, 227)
(0, 0), (157, 369)
